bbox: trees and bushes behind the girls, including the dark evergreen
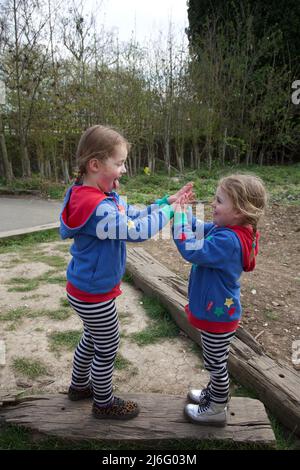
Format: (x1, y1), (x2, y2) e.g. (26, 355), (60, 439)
(0, 0), (300, 183)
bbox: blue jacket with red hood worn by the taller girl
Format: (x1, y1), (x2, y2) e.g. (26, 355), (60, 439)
(60, 185), (172, 294)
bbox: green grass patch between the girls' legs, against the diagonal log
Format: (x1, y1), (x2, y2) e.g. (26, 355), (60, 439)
(130, 295), (180, 346)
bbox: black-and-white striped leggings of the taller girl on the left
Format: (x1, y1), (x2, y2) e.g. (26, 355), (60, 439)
(67, 294), (120, 406)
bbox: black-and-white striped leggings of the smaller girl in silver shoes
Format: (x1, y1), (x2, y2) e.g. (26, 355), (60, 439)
(201, 331), (235, 403)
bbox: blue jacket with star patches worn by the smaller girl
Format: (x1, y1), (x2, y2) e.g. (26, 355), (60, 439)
(173, 214), (258, 333)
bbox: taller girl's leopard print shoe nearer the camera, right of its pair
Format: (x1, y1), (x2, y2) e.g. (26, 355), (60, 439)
(92, 397), (140, 420)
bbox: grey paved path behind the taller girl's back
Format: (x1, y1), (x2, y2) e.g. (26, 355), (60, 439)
(0, 196), (62, 233)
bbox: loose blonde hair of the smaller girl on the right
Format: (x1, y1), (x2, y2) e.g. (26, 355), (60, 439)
(218, 174), (267, 259)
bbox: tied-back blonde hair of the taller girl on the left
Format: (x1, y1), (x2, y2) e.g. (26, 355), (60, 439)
(76, 125), (131, 183)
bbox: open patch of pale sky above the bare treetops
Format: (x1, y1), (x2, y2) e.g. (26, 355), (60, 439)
(91, 0), (188, 43)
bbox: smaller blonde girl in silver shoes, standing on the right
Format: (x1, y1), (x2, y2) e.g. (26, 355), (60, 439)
(174, 174), (267, 426)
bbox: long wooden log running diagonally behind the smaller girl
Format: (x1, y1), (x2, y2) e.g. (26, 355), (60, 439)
(127, 248), (300, 436)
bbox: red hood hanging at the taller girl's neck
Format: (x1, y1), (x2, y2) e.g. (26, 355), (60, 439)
(62, 185), (107, 228)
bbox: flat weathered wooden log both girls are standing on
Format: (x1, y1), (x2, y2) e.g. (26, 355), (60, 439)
(0, 393), (276, 447)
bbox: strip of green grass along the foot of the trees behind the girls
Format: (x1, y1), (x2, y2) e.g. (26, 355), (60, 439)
(2, 163), (300, 204)
